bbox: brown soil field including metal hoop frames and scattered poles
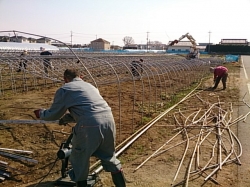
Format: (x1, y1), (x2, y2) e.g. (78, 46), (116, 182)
(0, 55), (243, 187)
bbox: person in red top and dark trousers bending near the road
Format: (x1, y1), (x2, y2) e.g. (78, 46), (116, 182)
(210, 66), (228, 90)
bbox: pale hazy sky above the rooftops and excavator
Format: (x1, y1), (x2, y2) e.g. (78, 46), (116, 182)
(0, 0), (250, 46)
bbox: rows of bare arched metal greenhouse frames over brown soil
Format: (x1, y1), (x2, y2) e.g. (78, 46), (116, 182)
(0, 48), (222, 140)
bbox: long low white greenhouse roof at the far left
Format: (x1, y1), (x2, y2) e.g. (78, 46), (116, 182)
(0, 42), (59, 51)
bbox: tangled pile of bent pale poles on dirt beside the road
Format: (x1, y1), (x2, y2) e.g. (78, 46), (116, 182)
(134, 95), (243, 186)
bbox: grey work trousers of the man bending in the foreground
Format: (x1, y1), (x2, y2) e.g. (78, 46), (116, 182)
(69, 113), (121, 182)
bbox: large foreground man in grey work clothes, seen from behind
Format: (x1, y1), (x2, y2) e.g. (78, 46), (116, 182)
(34, 69), (126, 187)
